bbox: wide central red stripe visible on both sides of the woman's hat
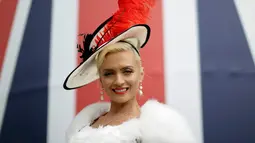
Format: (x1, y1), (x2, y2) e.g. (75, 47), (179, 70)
(76, 0), (165, 112)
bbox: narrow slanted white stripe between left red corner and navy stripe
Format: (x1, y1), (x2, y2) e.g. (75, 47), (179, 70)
(0, 0), (32, 131)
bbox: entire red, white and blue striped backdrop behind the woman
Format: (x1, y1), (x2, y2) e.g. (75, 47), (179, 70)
(0, 0), (255, 143)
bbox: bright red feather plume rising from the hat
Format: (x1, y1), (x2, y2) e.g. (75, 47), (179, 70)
(96, 0), (156, 46)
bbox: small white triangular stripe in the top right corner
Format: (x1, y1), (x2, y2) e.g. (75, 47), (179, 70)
(234, 0), (255, 63)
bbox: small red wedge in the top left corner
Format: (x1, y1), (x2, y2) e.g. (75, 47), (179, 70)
(0, 0), (17, 77)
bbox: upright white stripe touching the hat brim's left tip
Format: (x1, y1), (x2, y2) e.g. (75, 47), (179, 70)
(47, 0), (79, 143)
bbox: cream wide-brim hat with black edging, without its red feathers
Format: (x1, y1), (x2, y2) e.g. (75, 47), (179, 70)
(63, 17), (150, 90)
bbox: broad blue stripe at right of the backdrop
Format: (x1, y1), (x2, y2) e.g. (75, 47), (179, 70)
(198, 0), (255, 143)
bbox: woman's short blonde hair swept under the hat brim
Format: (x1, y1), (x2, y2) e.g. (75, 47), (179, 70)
(95, 42), (143, 71)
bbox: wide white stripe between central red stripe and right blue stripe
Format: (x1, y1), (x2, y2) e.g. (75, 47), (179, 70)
(163, 0), (203, 143)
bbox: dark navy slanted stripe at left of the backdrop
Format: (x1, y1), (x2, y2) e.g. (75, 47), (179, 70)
(0, 0), (52, 143)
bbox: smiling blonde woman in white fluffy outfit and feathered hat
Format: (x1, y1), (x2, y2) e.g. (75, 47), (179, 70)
(64, 0), (195, 143)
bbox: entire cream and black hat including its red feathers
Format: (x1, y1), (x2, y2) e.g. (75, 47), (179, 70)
(64, 0), (155, 90)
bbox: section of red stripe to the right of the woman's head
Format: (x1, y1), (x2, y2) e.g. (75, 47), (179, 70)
(140, 0), (165, 104)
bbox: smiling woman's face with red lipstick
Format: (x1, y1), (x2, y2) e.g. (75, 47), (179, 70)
(99, 50), (143, 103)
